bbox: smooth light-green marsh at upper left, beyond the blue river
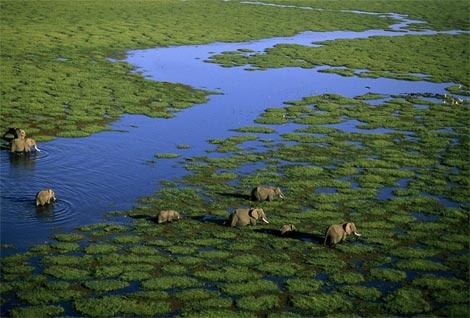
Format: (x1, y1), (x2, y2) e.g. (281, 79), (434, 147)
(0, 0), (404, 140)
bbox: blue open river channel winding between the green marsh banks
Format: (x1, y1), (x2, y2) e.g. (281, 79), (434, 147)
(0, 11), (460, 249)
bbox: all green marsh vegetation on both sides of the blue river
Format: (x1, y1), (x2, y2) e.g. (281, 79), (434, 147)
(0, 1), (470, 317)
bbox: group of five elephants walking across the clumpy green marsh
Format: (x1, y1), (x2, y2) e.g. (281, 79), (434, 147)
(155, 186), (361, 247)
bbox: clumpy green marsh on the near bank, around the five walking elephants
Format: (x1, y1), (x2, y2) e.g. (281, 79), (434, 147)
(2, 94), (470, 317)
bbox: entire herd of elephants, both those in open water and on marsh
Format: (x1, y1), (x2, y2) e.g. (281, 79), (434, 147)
(2, 128), (361, 247)
